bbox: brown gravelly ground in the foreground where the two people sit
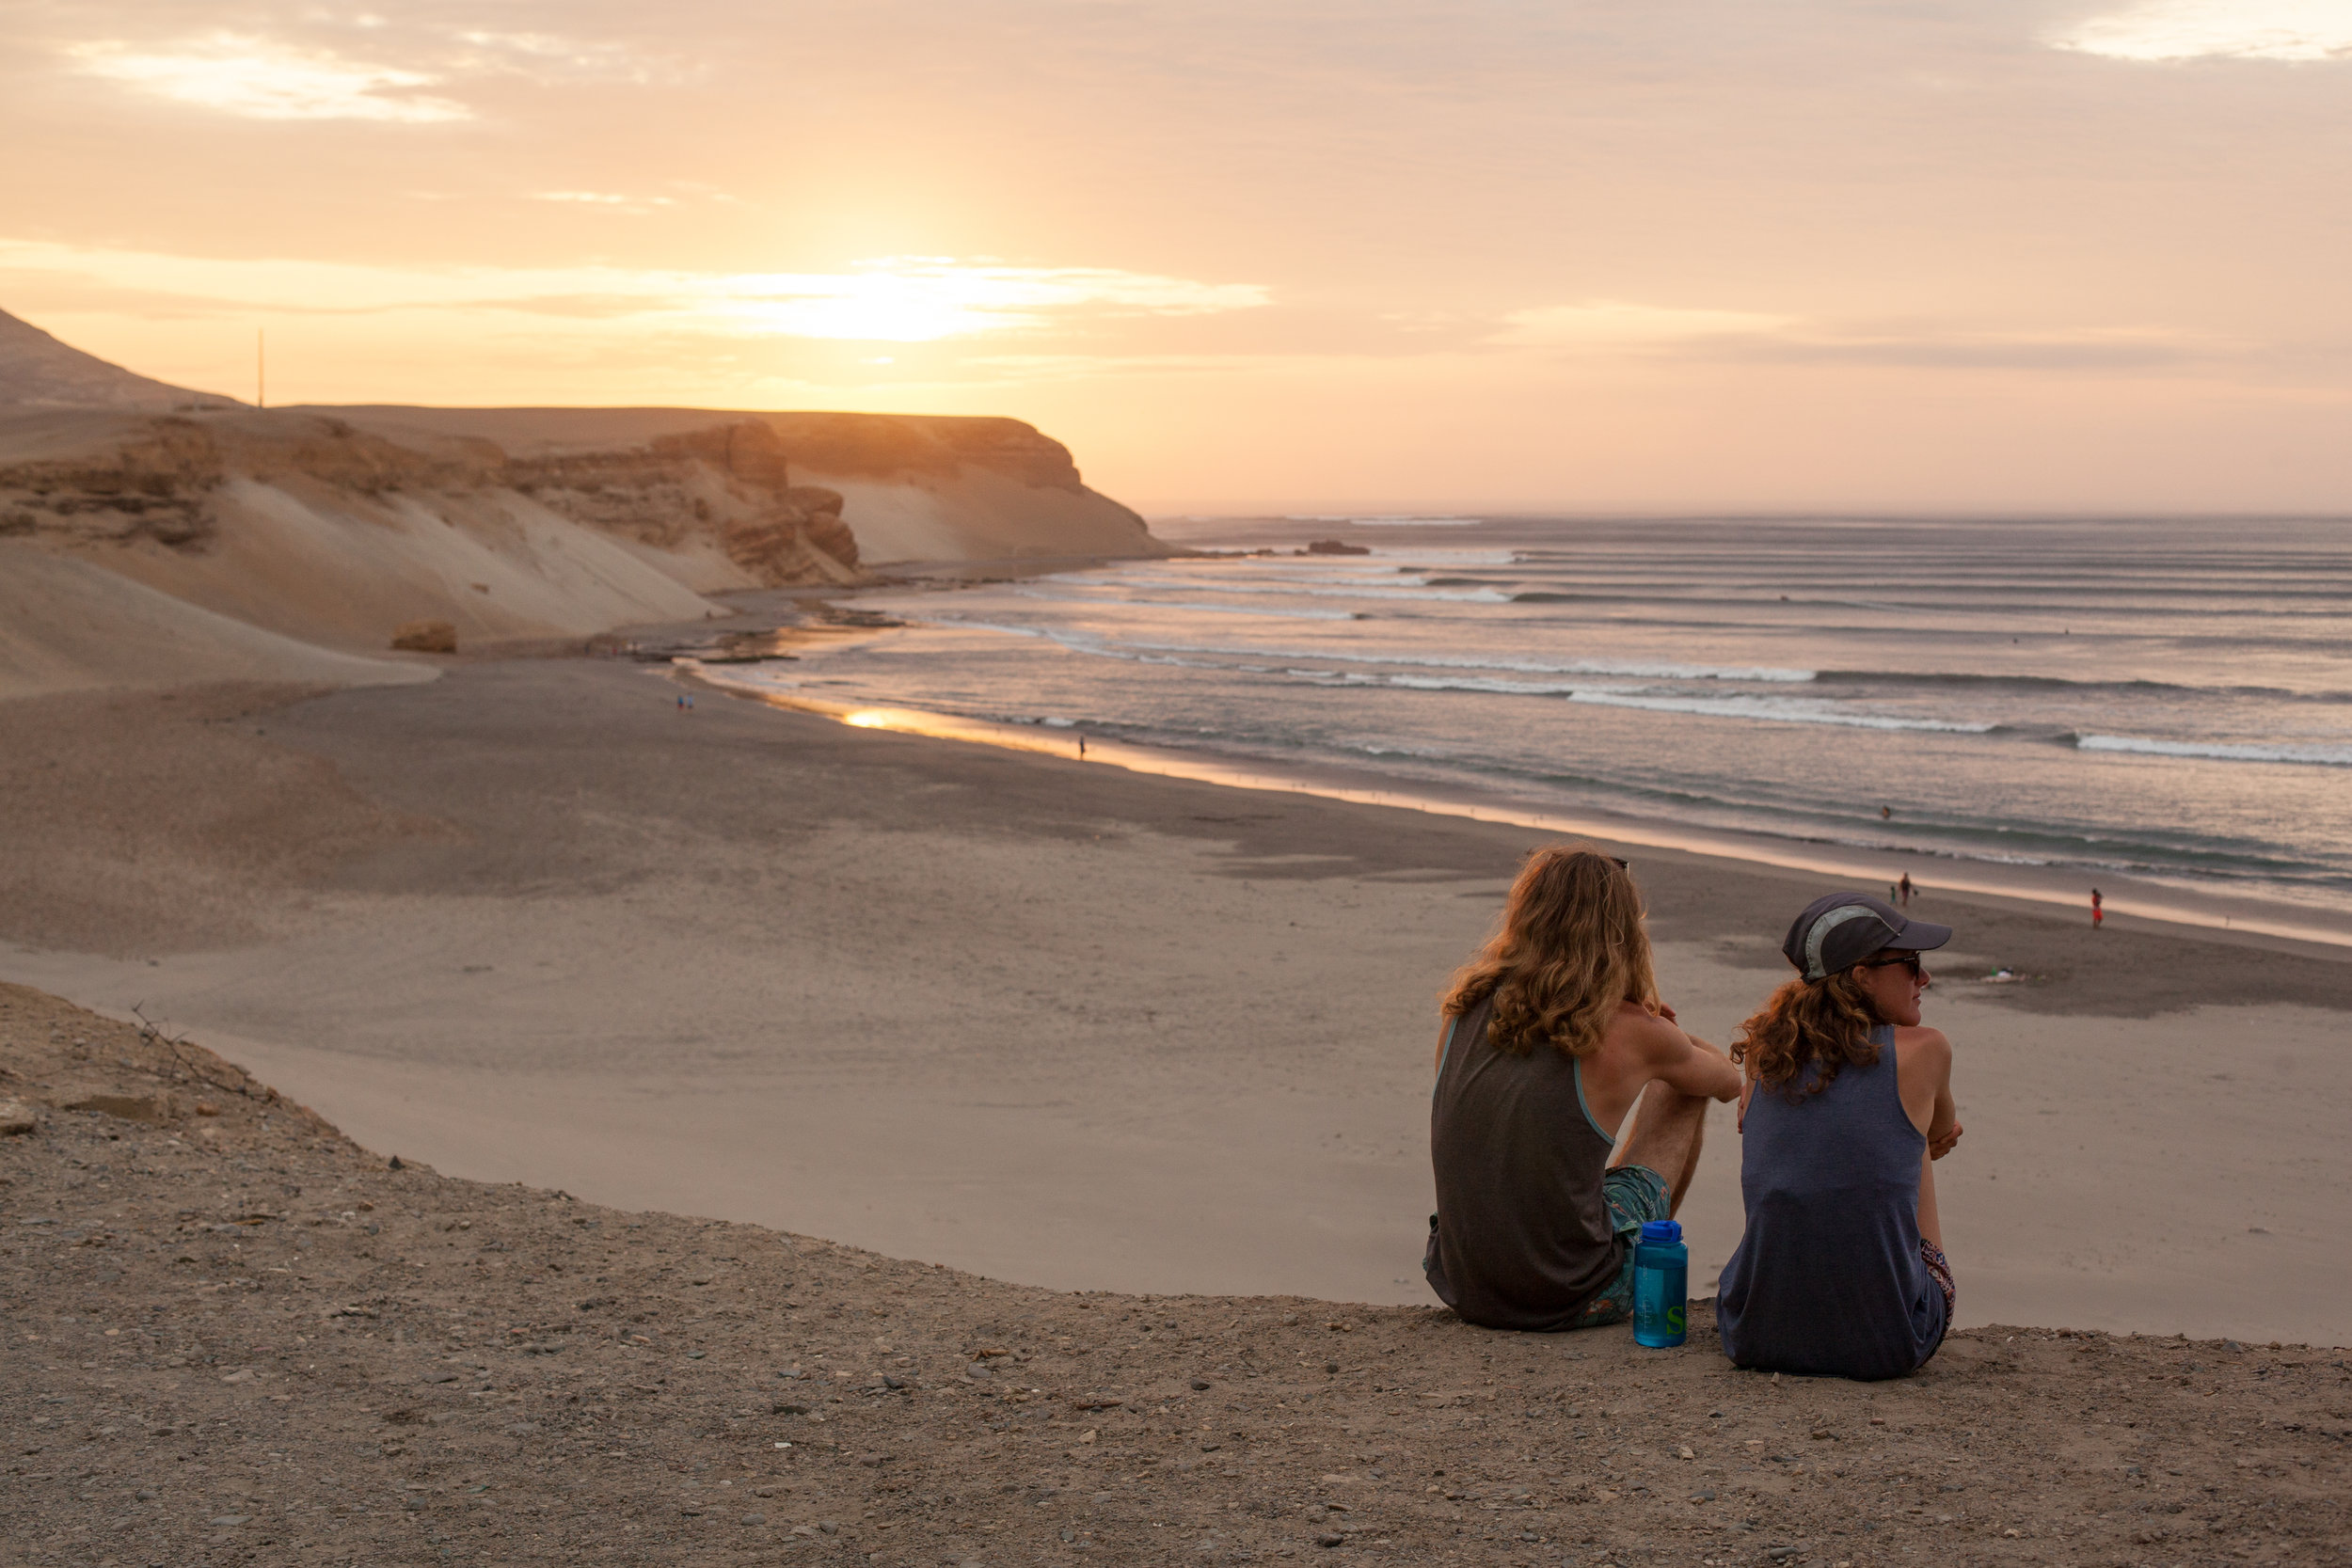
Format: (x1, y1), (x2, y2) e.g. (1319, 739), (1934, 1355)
(0, 988), (2352, 1568)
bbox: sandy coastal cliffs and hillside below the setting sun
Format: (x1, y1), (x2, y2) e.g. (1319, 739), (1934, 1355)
(0, 315), (1169, 701)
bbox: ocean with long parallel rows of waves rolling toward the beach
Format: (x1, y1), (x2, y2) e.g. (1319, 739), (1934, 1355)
(706, 517), (2352, 928)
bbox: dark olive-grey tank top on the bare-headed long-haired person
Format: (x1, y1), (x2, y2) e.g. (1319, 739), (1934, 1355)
(1421, 997), (1623, 1331)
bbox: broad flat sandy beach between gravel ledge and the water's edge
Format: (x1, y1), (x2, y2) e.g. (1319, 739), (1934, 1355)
(0, 660), (2352, 1345)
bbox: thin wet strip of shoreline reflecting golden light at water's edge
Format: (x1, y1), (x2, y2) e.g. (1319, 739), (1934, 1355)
(675, 658), (2352, 964)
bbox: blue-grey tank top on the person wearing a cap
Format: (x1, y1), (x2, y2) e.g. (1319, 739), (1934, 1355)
(1715, 1025), (1946, 1378)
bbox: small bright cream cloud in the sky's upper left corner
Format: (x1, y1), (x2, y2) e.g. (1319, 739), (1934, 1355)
(66, 33), (473, 124)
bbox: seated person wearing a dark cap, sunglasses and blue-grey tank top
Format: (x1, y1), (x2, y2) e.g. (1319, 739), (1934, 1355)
(1715, 894), (1960, 1378)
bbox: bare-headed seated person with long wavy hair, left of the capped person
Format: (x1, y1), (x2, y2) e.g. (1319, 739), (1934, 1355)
(1421, 847), (1740, 1331)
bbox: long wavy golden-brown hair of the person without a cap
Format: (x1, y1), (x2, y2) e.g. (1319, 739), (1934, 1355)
(1439, 844), (1659, 1055)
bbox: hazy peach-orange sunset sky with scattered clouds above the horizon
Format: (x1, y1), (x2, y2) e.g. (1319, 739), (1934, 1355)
(0, 0), (2352, 513)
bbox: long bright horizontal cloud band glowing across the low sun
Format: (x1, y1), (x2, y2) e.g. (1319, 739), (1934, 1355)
(0, 239), (1268, 343)
